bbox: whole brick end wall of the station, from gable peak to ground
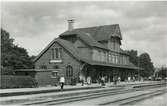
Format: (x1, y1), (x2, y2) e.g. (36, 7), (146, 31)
(35, 42), (80, 84)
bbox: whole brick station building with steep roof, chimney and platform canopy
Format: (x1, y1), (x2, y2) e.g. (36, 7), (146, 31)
(15, 20), (140, 85)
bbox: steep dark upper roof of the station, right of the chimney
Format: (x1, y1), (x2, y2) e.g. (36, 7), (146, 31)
(59, 24), (124, 53)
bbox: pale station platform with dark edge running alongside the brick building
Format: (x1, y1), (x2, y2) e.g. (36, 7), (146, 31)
(0, 81), (157, 97)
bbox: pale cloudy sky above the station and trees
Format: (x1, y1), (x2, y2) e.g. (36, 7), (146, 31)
(1, 1), (167, 66)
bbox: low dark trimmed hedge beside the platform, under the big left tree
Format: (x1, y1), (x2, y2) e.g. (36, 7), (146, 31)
(0, 75), (37, 89)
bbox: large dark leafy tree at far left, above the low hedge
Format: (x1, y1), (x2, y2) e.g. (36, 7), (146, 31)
(1, 29), (34, 74)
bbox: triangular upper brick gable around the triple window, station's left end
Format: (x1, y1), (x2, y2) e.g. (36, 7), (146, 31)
(35, 41), (80, 70)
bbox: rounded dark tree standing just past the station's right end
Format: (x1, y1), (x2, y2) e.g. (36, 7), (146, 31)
(139, 53), (154, 77)
